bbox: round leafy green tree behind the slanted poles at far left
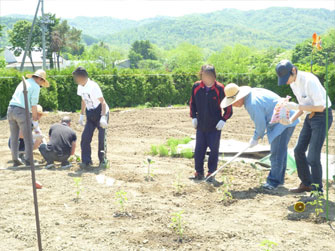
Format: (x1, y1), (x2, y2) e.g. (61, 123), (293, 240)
(8, 20), (41, 71)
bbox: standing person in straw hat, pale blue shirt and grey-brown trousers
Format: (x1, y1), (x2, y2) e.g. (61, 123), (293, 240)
(7, 70), (50, 166)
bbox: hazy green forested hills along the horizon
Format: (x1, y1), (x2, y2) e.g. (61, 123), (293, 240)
(0, 7), (335, 50)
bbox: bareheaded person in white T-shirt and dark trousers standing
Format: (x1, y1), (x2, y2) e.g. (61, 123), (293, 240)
(72, 67), (109, 168)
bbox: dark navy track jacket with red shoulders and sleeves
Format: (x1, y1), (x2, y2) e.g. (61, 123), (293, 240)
(190, 81), (233, 132)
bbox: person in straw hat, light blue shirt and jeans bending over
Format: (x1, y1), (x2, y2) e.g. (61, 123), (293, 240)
(221, 83), (299, 190)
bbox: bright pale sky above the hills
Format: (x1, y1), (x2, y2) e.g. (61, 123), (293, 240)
(0, 0), (335, 20)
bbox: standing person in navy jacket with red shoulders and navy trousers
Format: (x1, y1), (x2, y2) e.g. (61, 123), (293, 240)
(190, 65), (233, 182)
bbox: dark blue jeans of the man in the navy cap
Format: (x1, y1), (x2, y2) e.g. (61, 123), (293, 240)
(294, 109), (333, 191)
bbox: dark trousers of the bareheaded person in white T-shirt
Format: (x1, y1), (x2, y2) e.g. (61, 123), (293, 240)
(80, 105), (109, 163)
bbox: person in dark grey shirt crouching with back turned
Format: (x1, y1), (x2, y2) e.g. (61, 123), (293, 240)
(39, 116), (77, 169)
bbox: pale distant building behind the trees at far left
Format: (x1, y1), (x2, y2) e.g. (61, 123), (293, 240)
(4, 47), (66, 71)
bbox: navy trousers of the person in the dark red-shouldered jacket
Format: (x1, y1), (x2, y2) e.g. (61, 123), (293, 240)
(194, 130), (221, 174)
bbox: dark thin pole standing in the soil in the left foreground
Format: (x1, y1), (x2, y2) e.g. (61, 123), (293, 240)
(22, 76), (42, 251)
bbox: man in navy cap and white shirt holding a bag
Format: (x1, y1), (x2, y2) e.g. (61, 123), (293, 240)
(276, 60), (333, 193)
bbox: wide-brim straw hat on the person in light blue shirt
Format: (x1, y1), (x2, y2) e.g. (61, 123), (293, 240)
(221, 83), (251, 108)
